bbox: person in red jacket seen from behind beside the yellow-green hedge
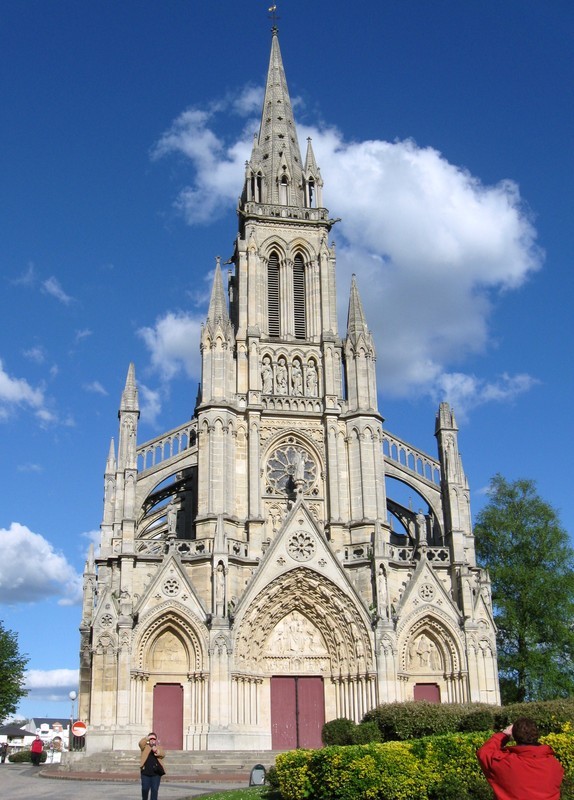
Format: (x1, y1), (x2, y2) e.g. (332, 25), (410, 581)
(476, 717), (564, 800)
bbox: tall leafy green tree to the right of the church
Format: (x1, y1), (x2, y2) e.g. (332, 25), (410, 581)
(474, 475), (574, 703)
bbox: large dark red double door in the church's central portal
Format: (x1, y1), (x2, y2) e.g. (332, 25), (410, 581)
(271, 676), (325, 750)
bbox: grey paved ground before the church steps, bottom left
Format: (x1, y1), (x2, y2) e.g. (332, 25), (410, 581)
(0, 763), (245, 800)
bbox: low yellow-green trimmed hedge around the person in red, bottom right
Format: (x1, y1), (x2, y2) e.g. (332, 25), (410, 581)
(276, 731), (574, 800)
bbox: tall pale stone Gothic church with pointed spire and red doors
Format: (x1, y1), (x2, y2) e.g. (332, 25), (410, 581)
(79, 27), (499, 751)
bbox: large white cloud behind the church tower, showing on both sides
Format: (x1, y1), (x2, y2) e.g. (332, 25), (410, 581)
(152, 89), (543, 415)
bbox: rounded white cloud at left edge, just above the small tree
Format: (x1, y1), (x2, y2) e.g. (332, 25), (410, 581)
(0, 522), (82, 605)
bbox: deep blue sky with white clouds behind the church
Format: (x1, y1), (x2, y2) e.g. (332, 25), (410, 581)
(0, 0), (574, 716)
